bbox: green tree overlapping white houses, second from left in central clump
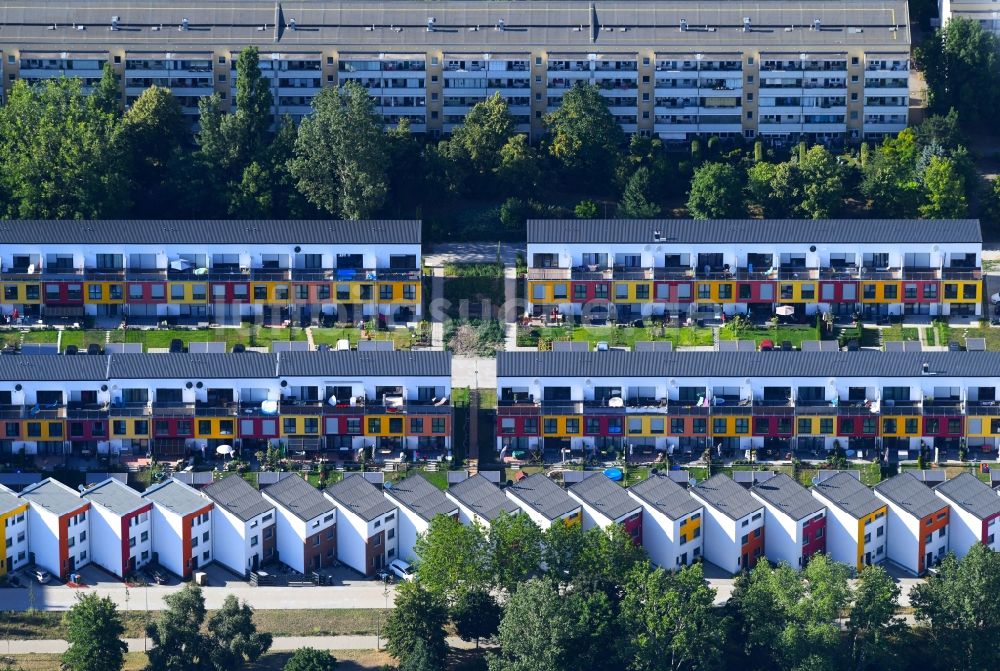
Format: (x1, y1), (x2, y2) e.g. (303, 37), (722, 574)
(487, 511), (542, 593)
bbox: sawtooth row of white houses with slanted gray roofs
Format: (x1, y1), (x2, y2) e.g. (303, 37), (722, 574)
(0, 470), (1000, 579)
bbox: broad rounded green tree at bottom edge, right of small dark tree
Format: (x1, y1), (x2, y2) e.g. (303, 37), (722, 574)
(488, 578), (624, 671)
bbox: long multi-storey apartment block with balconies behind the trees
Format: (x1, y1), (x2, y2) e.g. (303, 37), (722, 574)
(0, 0), (910, 141)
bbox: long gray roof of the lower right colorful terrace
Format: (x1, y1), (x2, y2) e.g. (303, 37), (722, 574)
(497, 350), (1000, 378)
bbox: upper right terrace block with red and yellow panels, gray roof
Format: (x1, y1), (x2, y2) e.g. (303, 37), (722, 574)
(527, 219), (982, 321)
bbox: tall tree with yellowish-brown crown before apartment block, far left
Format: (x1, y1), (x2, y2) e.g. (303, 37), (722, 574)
(116, 86), (191, 218)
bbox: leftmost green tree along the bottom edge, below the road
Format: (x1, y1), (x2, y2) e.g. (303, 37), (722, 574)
(62, 594), (128, 671)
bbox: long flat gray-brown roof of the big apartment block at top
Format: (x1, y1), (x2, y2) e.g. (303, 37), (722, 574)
(2, 0), (910, 51)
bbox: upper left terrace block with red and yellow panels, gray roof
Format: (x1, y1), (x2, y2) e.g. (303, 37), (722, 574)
(0, 220), (421, 325)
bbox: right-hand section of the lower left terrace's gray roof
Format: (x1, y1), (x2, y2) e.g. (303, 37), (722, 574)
(279, 350), (451, 377)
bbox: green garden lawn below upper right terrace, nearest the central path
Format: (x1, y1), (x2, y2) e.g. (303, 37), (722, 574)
(517, 325), (713, 349)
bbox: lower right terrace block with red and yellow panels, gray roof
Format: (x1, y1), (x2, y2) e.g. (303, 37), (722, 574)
(496, 351), (1000, 462)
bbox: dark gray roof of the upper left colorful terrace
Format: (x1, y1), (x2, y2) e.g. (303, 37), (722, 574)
(0, 220), (421, 245)
